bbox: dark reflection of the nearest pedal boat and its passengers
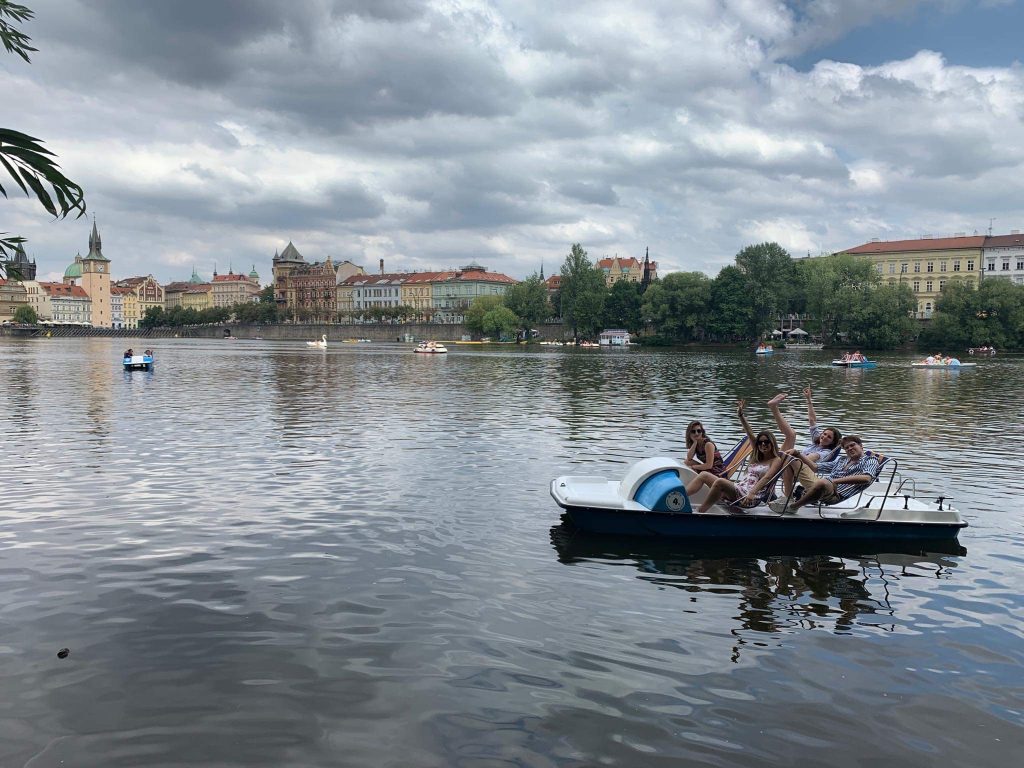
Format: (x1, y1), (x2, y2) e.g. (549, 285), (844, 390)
(551, 521), (967, 662)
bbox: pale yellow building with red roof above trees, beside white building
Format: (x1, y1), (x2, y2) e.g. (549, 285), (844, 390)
(842, 234), (985, 317)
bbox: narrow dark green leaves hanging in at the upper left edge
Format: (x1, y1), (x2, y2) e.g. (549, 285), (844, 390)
(0, 0), (85, 275)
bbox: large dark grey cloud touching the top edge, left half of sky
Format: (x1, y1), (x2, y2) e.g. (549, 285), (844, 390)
(41, 0), (524, 133)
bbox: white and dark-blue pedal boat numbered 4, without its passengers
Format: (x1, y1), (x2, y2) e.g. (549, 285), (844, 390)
(551, 458), (967, 541)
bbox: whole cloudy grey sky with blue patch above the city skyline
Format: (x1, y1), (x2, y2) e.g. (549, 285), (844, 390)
(0, 0), (1024, 283)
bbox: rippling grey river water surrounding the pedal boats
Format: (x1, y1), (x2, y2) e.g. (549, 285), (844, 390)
(0, 339), (1024, 768)
